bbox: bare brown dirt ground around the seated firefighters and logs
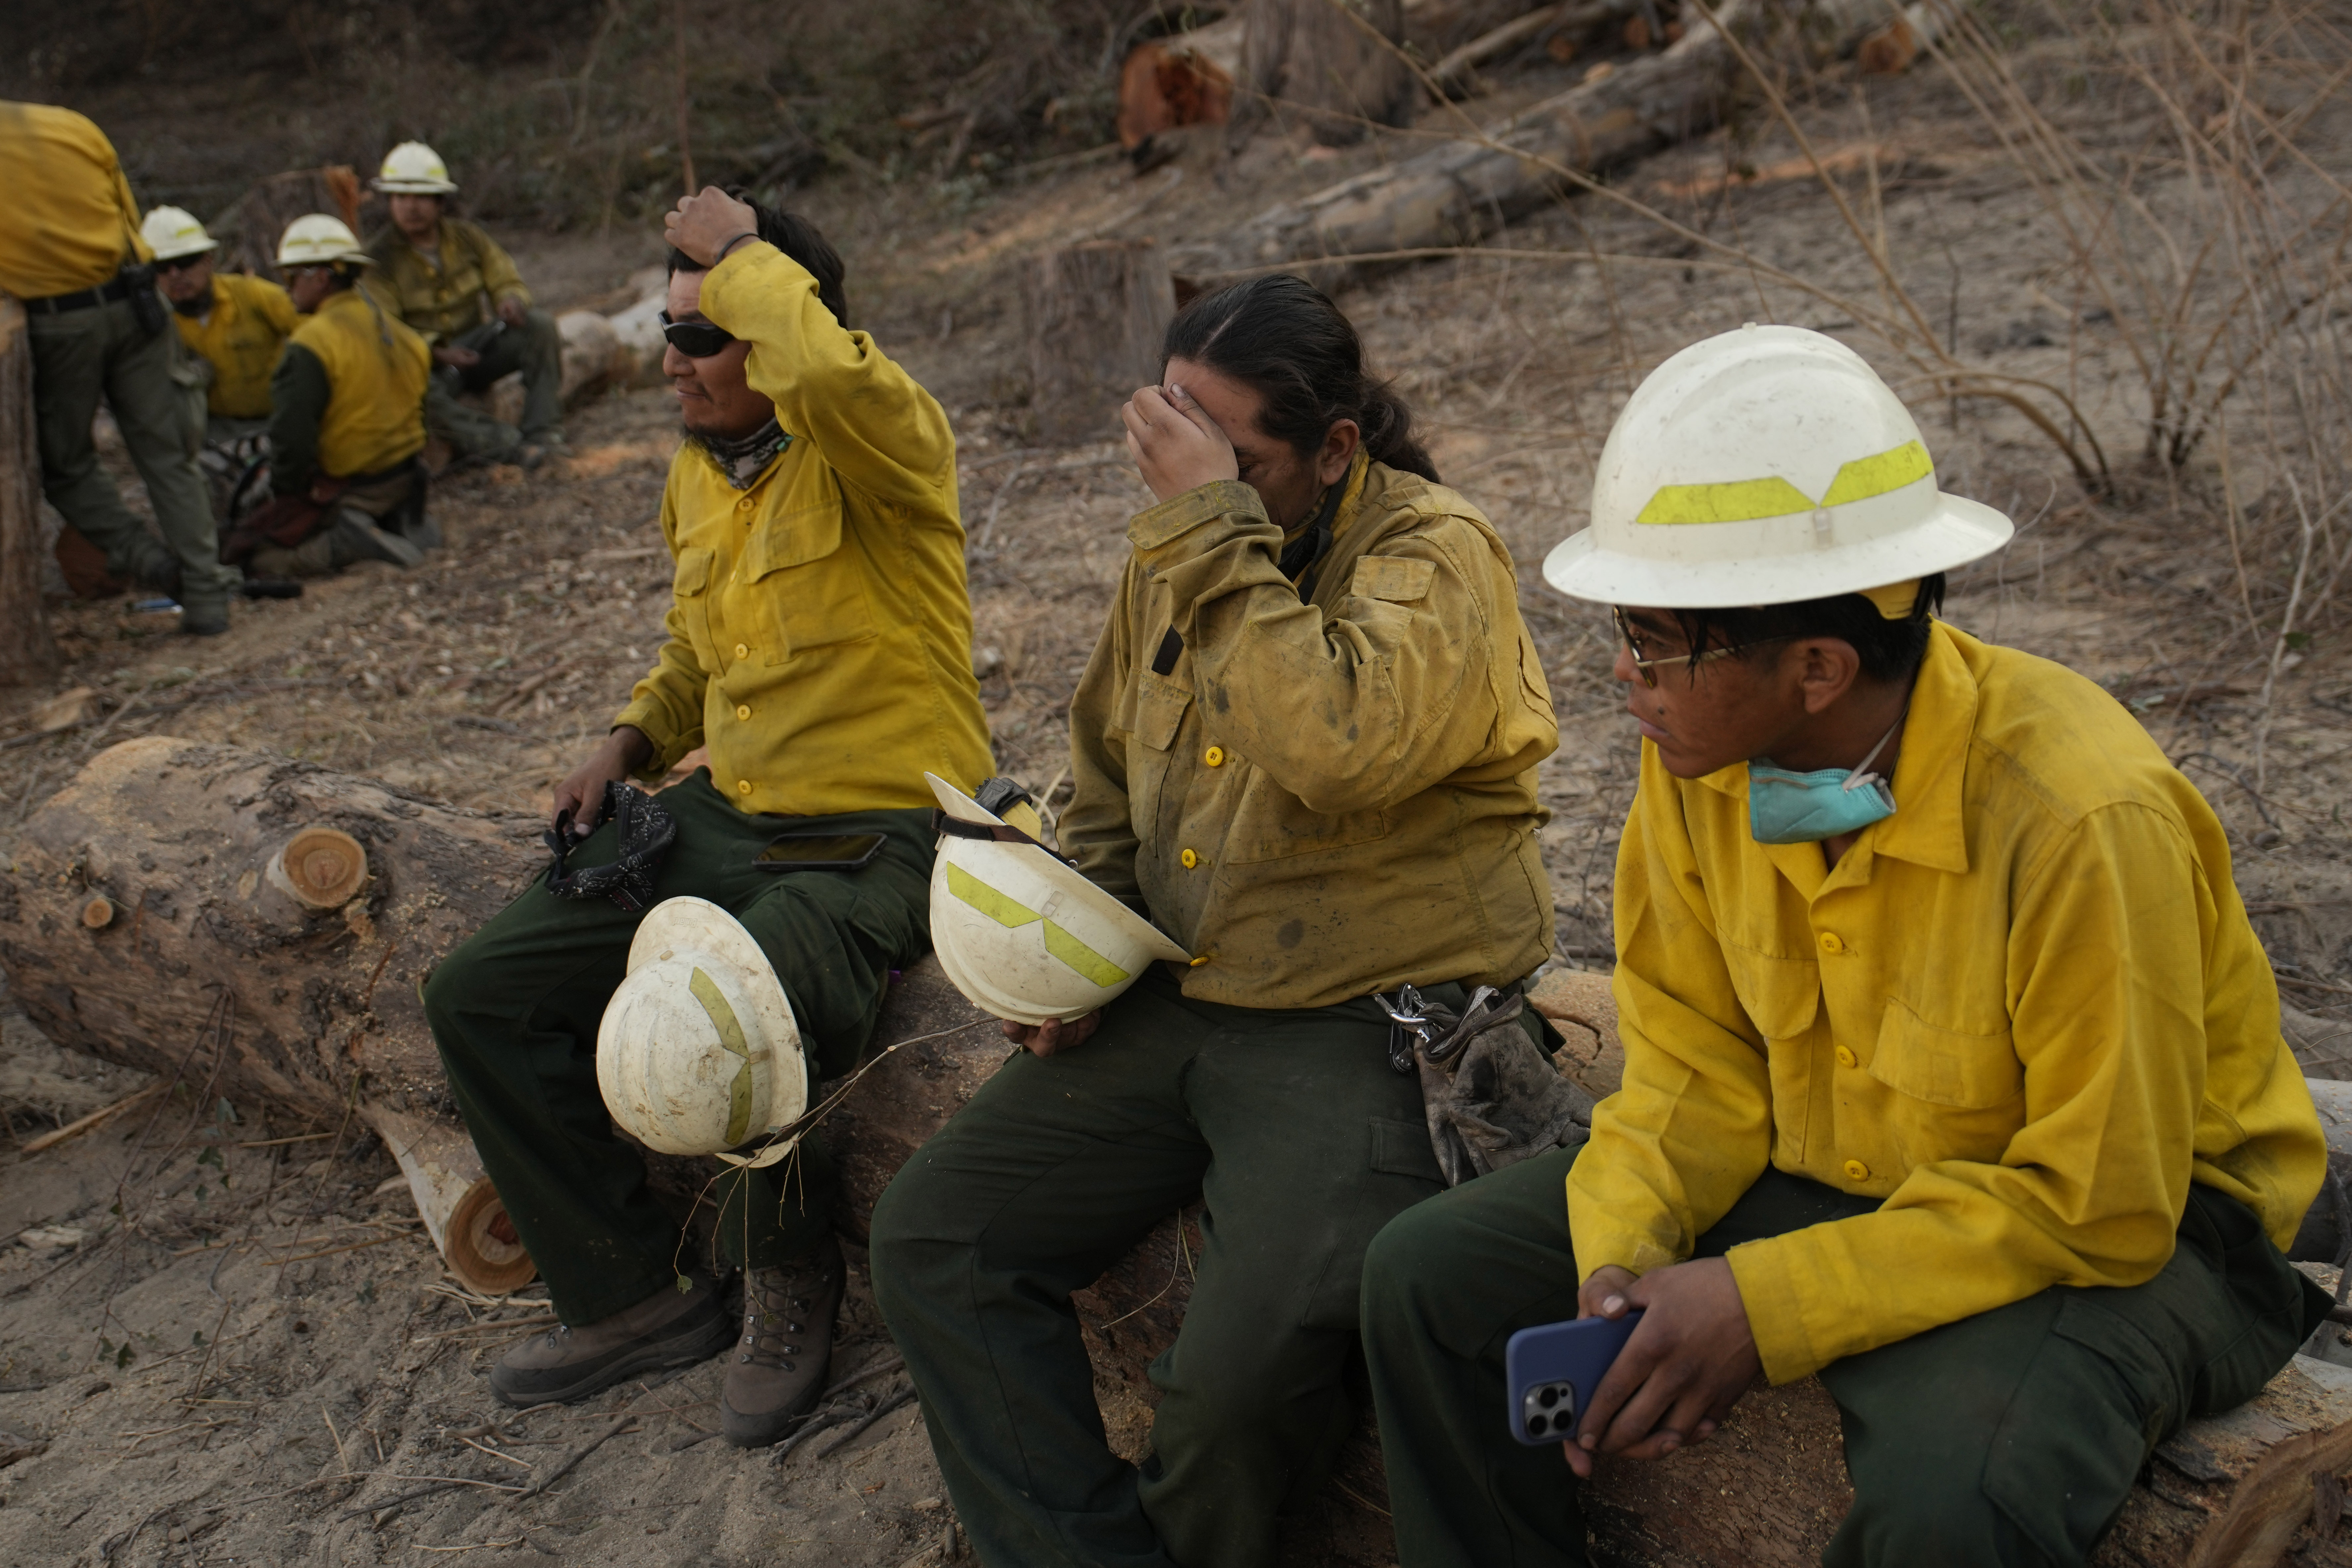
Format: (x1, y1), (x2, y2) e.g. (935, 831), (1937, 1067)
(0, 18), (2352, 1568)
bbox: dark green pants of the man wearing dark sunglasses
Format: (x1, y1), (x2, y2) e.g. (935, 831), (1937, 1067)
(426, 769), (934, 1326)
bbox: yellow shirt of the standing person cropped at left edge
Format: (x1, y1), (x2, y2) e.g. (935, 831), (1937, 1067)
(0, 103), (153, 298)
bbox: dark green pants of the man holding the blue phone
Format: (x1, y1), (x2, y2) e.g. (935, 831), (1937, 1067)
(1364, 1152), (2326, 1568)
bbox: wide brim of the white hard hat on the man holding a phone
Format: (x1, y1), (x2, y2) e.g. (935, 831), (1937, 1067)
(1543, 494), (2016, 609)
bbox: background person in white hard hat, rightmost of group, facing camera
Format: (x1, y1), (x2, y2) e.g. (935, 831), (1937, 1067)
(367, 141), (564, 468)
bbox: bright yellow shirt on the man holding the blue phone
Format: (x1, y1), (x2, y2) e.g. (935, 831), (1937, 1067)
(1569, 623), (2326, 1382)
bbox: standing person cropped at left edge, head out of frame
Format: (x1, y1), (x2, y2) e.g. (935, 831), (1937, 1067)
(0, 103), (235, 635)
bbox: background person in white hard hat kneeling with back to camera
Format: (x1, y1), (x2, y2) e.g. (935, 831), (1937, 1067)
(221, 212), (440, 578)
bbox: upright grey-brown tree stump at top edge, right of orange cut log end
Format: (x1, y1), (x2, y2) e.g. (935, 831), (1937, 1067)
(1228, 0), (1423, 150)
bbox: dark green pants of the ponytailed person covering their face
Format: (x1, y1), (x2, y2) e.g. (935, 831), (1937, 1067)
(873, 966), (1524, 1568)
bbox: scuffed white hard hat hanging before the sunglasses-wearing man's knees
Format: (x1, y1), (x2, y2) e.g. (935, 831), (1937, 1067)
(595, 898), (809, 1154)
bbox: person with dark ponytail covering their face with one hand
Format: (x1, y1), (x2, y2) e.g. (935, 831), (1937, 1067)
(873, 277), (1559, 1568)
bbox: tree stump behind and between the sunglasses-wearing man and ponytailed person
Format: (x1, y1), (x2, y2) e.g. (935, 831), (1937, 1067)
(1023, 240), (1176, 442)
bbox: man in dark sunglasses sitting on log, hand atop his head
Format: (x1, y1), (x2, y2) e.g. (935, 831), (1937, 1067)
(426, 188), (990, 1446)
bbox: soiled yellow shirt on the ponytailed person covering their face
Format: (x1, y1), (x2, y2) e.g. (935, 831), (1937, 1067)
(1058, 456), (1559, 1008)
